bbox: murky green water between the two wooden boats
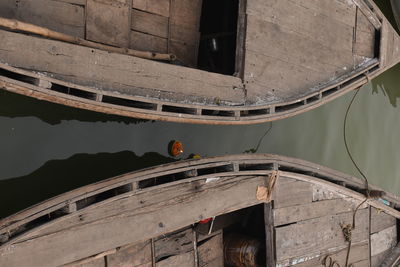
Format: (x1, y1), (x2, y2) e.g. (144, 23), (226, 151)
(0, 1), (400, 218)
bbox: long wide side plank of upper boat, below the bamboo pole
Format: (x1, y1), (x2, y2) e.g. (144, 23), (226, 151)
(0, 31), (244, 103)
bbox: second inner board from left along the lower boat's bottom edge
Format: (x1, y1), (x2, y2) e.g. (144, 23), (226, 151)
(107, 240), (152, 267)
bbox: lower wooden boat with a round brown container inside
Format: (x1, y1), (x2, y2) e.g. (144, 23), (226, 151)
(0, 154), (400, 267)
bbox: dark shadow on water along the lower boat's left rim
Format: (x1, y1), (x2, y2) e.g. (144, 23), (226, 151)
(0, 151), (175, 221)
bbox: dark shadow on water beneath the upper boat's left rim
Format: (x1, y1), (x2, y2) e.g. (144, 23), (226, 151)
(0, 90), (153, 125)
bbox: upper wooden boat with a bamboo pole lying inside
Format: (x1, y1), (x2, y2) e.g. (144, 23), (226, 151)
(0, 0), (400, 124)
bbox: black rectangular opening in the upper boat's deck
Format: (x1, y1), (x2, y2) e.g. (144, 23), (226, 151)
(198, 0), (239, 75)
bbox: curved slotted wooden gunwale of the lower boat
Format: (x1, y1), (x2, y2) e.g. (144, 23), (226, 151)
(0, 154), (400, 248)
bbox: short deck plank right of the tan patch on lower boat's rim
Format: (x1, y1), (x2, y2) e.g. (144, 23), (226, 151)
(272, 177), (312, 209)
